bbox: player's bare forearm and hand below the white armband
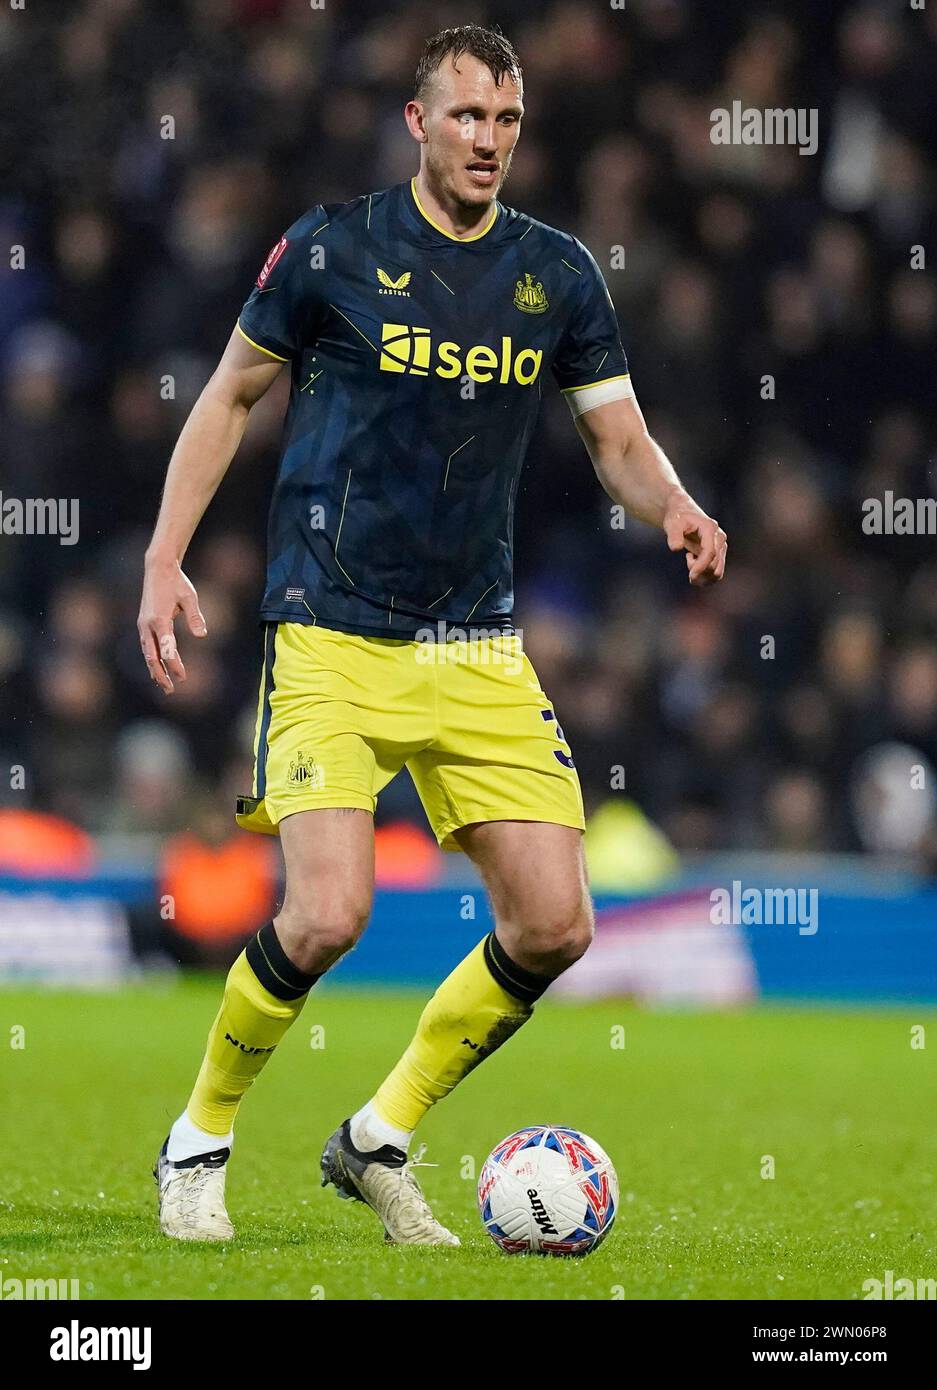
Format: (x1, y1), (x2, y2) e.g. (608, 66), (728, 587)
(576, 395), (727, 585)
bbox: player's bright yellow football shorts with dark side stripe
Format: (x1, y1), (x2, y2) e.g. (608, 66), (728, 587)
(238, 623), (585, 849)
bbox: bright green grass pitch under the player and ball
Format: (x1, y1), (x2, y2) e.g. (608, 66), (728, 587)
(0, 977), (937, 1300)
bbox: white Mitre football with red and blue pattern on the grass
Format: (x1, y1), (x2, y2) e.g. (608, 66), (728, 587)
(478, 1125), (619, 1255)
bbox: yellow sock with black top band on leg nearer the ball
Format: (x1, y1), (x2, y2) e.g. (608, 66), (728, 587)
(371, 931), (552, 1133)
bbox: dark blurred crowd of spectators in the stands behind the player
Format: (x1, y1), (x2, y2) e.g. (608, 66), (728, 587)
(0, 0), (937, 853)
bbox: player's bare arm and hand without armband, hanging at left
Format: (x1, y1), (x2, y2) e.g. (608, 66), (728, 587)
(136, 328), (284, 695)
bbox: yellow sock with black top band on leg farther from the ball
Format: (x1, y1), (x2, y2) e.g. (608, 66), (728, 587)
(186, 922), (318, 1134)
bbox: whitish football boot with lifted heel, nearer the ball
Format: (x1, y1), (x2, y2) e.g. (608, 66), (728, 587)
(321, 1120), (462, 1245)
